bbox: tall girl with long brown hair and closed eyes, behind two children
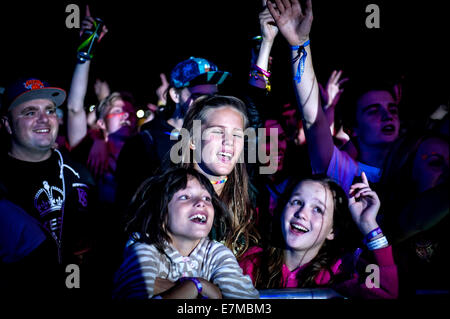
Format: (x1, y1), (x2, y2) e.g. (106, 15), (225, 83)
(167, 95), (260, 258)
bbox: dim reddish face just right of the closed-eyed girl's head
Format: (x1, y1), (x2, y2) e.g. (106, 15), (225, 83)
(261, 120), (287, 171)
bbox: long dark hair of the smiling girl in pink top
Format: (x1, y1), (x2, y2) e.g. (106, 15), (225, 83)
(253, 175), (359, 289)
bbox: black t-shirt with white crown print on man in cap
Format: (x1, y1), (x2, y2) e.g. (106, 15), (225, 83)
(0, 151), (94, 264)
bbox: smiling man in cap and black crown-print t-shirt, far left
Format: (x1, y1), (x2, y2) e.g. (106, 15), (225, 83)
(0, 78), (93, 298)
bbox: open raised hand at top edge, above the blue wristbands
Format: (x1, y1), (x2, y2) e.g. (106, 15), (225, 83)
(267, 0), (313, 46)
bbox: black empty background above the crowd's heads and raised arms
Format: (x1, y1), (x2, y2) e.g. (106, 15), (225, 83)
(0, 0), (450, 120)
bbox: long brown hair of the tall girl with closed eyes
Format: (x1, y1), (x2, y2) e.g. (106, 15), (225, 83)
(177, 95), (260, 258)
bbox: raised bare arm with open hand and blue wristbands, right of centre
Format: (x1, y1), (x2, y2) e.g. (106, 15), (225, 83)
(267, 0), (334, 172)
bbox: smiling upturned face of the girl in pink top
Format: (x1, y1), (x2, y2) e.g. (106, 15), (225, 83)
(281, 180), (334, 254)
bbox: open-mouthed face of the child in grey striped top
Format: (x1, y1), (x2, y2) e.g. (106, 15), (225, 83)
(168, 177), (214, 247)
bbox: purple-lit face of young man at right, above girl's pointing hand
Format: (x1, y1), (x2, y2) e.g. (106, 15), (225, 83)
(354, 91), (400, 146)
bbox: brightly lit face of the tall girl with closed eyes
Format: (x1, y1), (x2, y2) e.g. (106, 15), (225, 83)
(194, 106), (244, 177)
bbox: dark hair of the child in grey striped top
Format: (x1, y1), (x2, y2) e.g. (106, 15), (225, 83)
(125, 167), (231, 251)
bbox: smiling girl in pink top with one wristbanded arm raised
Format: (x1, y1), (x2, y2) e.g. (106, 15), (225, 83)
(240, 173), (398, 298)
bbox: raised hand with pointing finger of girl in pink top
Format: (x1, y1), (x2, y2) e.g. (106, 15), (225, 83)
(348, 172), (380, 236)
